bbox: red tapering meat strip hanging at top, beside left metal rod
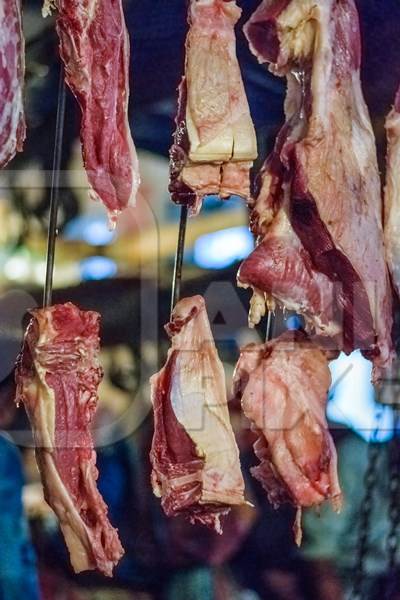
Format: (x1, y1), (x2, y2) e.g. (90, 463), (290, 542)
(43, 0), (140, 223)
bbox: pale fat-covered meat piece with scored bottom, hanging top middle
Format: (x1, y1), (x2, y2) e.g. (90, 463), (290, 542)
(169, 0), (257, 214)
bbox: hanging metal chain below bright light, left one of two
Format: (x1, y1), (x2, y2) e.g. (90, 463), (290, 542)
(351, 407), (382, 600)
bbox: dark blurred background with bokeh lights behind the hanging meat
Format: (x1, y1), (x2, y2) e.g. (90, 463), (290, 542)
(0, 0), (400, 600)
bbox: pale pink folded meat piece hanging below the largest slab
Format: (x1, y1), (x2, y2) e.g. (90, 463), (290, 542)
(233, 332), (341, 543)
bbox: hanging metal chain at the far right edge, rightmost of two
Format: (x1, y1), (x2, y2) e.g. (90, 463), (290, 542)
(385, 407), (400, 600)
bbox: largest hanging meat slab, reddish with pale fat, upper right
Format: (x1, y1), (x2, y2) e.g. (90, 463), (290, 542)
(238, 0), (392, 380)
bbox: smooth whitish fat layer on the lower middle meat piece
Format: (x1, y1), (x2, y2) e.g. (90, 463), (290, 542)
(170, 298), (244, 504)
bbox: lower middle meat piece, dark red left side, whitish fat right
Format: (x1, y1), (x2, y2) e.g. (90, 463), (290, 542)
(150, 296), (244, 533)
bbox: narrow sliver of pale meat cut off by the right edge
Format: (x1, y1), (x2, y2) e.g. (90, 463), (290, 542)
(385, 88), (400, 297)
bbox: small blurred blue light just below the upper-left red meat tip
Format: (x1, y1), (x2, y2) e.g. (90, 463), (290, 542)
(63, 215), (115, 246)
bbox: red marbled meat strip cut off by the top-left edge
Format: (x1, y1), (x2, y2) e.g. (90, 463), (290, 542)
(0, 0), (26, 168)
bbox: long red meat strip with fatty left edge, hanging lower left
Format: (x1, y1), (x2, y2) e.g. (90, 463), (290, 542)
(16, 303), (124, 576)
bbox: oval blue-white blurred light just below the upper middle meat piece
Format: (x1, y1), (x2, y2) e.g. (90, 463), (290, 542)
(193, 226), (254, 269)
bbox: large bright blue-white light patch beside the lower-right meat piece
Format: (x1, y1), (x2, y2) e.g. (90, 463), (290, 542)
(327, 350), (393, 442)
